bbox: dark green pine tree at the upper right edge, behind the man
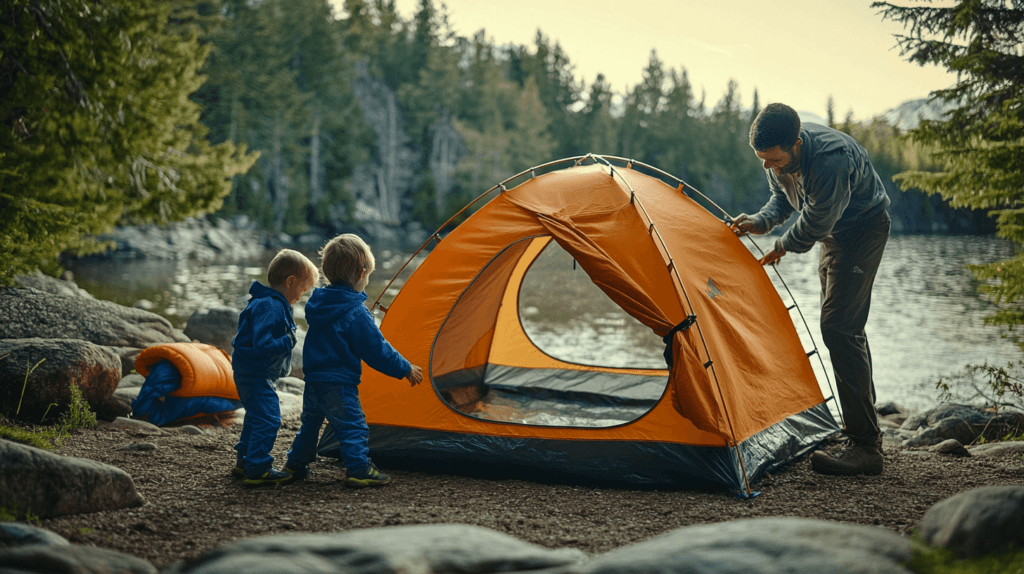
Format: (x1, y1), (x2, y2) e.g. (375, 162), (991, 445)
(871, 0), (1024, 327)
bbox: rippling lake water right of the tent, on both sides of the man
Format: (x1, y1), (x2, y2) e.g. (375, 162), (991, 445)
(763, 235), (1022, 409)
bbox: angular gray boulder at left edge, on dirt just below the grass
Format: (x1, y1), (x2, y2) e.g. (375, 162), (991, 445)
(0, 439), (143, 518)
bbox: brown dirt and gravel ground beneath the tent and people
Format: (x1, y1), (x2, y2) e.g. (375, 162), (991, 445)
(42, 425), (1024, 568)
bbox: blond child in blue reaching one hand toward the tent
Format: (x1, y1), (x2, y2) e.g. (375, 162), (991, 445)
(285, 233), (423, 488)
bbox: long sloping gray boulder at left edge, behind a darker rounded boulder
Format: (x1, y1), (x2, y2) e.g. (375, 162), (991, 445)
(0, 279), (189, 349)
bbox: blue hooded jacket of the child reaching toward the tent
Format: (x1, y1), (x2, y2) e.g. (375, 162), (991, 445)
(302, 284), (412, 385)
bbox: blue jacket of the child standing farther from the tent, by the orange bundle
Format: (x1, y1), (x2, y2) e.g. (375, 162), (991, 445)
(231, 281), (295, 380)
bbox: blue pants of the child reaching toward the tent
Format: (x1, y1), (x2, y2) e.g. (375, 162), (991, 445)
(288, 381), (370, 473)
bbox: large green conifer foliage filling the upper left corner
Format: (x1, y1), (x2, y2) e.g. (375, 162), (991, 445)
(0, 0), (255, 284)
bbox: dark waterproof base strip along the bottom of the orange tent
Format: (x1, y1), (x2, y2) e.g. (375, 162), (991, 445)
(318, 403), (838, 490)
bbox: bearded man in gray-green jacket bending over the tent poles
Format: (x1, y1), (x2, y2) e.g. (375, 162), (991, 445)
(732, 103), (891, 475)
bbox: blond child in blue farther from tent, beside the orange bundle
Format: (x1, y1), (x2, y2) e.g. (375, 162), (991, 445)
(231, 250), (319, 486)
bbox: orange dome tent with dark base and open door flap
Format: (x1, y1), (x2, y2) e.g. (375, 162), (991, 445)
(319, 156), (838, 492)
